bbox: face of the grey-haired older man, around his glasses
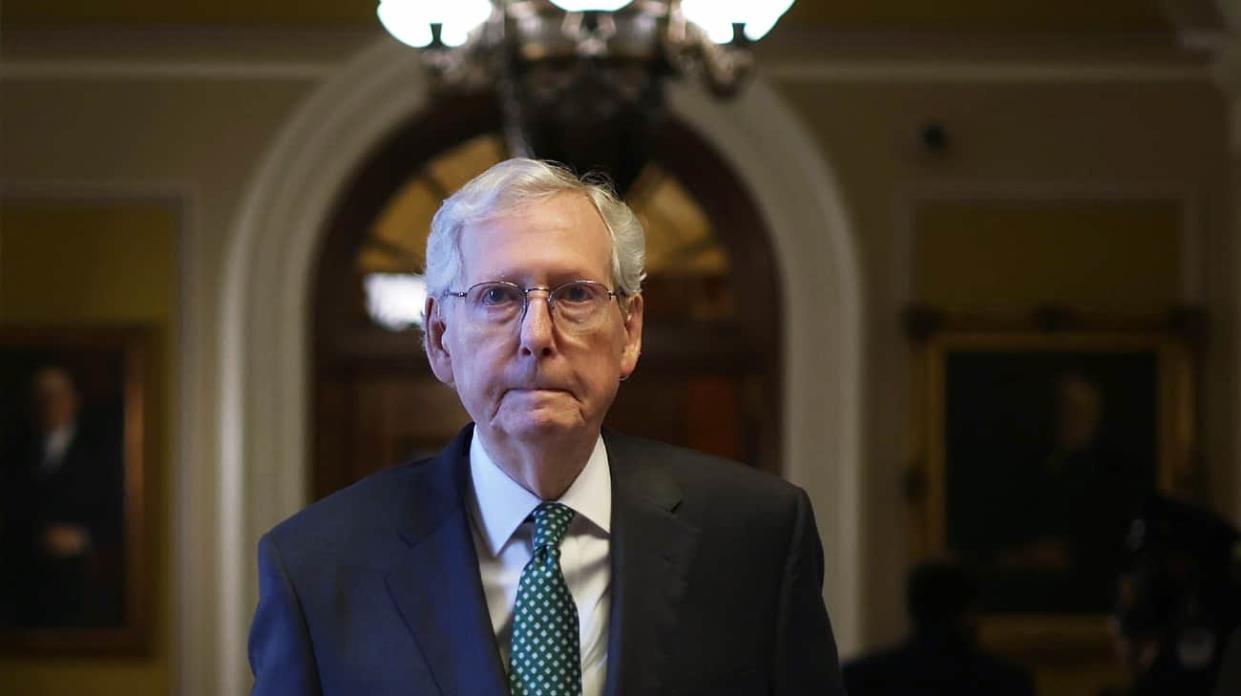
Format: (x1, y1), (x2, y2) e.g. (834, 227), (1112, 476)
(427, 194), (642, 443)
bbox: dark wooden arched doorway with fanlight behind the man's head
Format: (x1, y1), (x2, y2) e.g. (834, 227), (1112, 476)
(313, 97), (782, 497)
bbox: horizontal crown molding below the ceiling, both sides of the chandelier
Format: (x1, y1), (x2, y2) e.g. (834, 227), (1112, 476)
(0, 26), (1212, 83)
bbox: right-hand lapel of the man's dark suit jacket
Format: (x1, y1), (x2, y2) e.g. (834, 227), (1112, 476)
(604, 433), (699, 696)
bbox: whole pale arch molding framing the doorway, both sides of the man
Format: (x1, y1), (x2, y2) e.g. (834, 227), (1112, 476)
(203, 38), (864, 694)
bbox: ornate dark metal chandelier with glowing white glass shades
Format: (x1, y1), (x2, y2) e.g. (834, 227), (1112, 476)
(379, 0), (793, 192)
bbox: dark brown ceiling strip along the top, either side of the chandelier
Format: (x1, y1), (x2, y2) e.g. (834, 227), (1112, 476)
(0, 0), (1170, 33)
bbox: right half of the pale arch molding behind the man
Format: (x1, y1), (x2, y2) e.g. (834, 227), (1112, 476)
(670, 79), (865, 653)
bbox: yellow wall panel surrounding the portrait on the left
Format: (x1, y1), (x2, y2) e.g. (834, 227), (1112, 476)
(0, 200), (180, 696)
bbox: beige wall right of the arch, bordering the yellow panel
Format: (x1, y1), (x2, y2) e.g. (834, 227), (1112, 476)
(783, 74), (1232, 640)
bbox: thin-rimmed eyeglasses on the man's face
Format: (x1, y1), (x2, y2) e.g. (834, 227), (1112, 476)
(444, 280), (621, 332)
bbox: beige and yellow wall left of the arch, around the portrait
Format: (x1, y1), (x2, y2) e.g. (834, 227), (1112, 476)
(0, 73), (304, 696)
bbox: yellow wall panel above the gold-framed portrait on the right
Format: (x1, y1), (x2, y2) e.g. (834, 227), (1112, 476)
(915, 200), (1183, 313)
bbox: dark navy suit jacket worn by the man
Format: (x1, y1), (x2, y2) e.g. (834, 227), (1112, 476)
(249, 428), (844, 696)
